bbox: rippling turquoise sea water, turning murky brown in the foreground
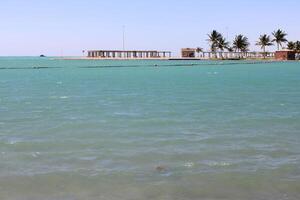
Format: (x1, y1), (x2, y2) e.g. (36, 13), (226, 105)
(0, 58), (300, 200)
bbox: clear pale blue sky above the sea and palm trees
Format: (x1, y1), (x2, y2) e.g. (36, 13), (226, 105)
(0, 0), (300, 56)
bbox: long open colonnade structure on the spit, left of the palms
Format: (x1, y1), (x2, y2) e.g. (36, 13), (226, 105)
(88, 50), (172, 59)
